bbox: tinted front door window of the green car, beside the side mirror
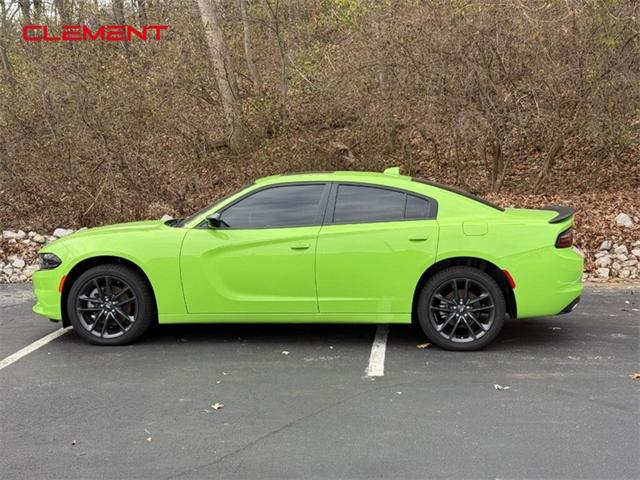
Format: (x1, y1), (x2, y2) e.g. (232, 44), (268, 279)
(221, 184), (325, 228)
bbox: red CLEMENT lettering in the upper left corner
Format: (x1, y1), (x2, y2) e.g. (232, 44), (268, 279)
(22, 25), (169, 42)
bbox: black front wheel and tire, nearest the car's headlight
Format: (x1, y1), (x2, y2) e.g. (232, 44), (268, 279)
(66, 264), (155, 345)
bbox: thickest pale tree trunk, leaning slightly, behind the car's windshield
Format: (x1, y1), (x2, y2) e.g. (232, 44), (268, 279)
(198, 0), (247, 151)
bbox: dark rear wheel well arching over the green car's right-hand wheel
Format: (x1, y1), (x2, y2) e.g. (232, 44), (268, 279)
(411, 257), (518, 321)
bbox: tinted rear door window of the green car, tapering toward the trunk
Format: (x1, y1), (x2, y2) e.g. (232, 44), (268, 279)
(333, 185), (432, 223)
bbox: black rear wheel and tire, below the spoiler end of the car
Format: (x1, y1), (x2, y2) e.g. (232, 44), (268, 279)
(417, 267), (506, 351)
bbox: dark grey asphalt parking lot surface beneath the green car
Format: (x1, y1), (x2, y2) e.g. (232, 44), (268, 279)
(0, 285), (640, 479)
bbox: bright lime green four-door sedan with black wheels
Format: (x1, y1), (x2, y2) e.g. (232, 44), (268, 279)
(33, 168), (583, 350)
